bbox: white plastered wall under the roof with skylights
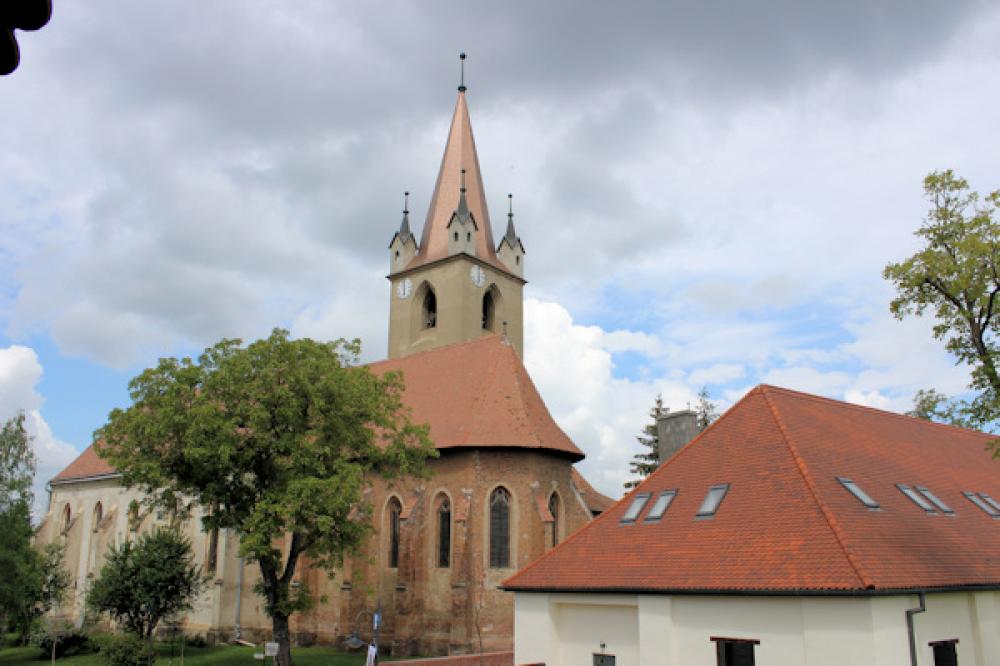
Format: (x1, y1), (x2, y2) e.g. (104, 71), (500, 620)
(514, 592), (1000, 666)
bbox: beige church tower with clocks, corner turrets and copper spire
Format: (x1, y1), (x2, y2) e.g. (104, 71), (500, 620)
(388, 59), (525, 358)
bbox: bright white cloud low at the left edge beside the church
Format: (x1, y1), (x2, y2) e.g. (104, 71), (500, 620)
(0, 345), (79, 518)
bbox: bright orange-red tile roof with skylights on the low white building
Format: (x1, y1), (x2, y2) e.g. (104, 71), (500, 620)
(504, 386), (1000, 593)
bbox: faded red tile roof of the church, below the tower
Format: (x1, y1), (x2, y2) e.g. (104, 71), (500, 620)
(53, 335), (584, 480)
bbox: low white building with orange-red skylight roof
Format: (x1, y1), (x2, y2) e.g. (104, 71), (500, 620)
(504, 386), (1000, 666)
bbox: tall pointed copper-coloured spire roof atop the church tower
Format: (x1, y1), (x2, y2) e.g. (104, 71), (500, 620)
(404, 90), (509, 272)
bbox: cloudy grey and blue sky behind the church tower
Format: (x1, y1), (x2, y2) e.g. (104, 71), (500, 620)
(0, 0), (1000, 510)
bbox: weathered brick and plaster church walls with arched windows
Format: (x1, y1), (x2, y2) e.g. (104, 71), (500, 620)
(37, 448), (591, 655)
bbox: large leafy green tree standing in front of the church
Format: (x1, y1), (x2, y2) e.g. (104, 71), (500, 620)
(95, 329), (436, 666)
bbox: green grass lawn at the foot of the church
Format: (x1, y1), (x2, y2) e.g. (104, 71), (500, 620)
(0, 643), (378, 666)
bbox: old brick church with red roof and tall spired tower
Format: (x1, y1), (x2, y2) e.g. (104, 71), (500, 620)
(38, 74), (612, 655)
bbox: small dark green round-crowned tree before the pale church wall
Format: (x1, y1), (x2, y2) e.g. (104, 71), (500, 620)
(87, 529), (204, 662)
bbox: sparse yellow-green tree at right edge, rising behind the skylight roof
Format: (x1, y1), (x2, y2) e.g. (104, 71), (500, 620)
(883, 170), (1000, 428)
